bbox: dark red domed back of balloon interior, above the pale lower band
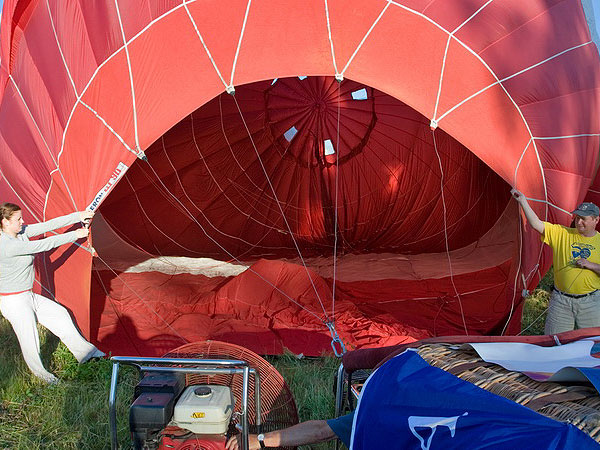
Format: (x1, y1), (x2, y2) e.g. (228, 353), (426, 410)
(101, 77), (510, 260)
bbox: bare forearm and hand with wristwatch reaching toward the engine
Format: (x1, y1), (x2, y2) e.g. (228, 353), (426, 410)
(225, 420), (336, 450)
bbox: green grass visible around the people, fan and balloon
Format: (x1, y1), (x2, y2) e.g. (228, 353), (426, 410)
(0, 281), (548, 450)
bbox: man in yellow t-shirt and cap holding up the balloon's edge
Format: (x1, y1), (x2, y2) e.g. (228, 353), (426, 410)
(511, 189), (600, 334)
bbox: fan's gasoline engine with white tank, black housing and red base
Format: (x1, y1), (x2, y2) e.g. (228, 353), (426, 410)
(129, 372), (235, 450)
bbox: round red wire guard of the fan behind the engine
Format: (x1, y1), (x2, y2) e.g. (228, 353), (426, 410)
(164, 341), (298, 433)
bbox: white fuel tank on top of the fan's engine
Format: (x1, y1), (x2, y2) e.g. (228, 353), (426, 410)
(172, 384), (235, 434)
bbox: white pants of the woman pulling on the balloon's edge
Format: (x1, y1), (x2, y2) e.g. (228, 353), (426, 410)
(0, 291), (96, 381)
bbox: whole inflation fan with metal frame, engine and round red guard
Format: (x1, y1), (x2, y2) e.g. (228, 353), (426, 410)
(108, 341), (298, 450)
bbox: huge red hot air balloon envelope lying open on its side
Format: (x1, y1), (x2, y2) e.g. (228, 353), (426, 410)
(0, 0), (600, 355)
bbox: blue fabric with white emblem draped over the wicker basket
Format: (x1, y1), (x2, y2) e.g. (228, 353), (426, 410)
(350, 351), (600, 450)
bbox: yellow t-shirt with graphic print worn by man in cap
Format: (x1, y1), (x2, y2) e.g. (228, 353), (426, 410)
(542, 222), (600, 294)
